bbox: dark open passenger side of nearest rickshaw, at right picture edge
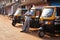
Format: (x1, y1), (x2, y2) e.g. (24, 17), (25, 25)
(55, 7), (60, 33)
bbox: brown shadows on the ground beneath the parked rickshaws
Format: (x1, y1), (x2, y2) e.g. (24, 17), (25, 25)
(15, 25), (60, 40)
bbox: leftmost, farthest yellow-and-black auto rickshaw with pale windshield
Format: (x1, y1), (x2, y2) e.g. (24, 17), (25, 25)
(12, 8), (27, 26)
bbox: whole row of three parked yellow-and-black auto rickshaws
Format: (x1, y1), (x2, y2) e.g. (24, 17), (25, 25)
(12, 6), (60, 37)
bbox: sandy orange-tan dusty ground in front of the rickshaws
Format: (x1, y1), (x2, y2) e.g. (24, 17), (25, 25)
(0, 15), (60, 40)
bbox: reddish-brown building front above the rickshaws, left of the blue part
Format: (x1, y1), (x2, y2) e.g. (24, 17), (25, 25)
(21, 0), (48, 8)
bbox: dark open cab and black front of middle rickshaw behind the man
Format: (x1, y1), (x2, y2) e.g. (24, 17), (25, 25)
(30, 9), (42, 28)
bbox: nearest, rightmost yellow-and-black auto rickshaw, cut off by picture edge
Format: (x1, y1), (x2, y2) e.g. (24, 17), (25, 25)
(39, 6), (60, 37)
